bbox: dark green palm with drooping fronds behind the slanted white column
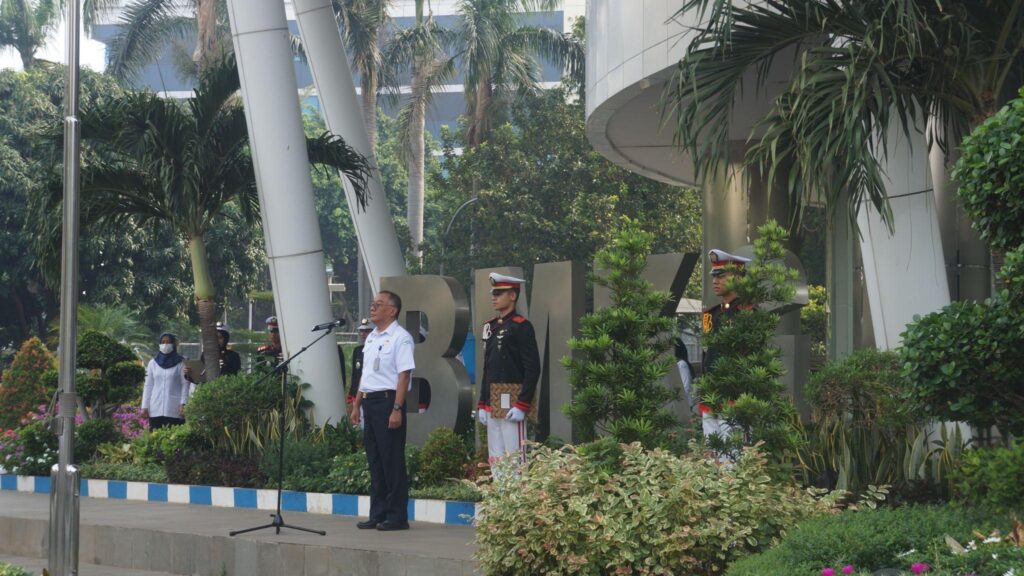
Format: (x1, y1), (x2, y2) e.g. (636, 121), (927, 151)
(67, 52), (369, 378)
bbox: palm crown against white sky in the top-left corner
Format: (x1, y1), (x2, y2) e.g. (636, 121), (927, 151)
(0, 0), (118, 70)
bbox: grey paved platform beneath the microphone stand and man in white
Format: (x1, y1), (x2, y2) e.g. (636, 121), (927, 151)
(0, 491), (476, 576)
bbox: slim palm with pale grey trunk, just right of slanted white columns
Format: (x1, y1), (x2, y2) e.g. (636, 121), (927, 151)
(385, 0), (455, 263)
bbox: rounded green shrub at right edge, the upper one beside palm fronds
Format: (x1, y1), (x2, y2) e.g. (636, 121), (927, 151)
(951, 85), (1024, 249)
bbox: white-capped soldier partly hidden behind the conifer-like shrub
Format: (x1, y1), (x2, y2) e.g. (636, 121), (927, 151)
(698, 249), (751, 439)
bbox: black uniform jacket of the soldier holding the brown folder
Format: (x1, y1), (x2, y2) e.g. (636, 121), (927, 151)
(477, 312), (541, 413)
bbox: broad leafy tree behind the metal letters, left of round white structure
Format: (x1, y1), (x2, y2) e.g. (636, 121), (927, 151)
(425, 88), (700, 285)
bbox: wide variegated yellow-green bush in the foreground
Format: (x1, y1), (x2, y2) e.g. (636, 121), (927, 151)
(476, 444), (835, 575)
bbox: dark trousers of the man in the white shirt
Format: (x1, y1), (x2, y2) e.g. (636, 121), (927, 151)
(361, 393), (409, 524)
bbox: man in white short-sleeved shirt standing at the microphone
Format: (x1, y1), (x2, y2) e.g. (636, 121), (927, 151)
(349, 290), (416, 532)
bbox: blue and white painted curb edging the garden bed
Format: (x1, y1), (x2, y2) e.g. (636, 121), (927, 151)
(0, 475), (476, 526)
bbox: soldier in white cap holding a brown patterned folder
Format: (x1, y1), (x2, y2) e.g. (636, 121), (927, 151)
(476, 273), (541, 466)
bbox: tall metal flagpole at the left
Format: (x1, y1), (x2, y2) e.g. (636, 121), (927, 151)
(49, 0), (81, 576)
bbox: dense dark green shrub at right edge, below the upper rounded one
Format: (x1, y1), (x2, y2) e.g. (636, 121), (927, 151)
(901, 290), (1024, 436)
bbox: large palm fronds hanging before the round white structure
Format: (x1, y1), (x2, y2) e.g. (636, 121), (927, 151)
(664, 0), (1024, 225)
